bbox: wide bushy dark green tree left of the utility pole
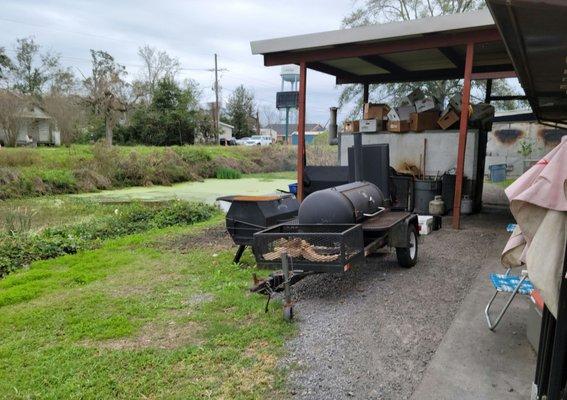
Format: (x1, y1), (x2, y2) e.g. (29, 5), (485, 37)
(122, 78), (200, 146)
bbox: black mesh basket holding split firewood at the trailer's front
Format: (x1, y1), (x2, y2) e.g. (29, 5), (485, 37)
(253, 223), (364, 272)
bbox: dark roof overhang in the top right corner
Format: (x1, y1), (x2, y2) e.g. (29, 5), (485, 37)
(487, 0), (567, 124)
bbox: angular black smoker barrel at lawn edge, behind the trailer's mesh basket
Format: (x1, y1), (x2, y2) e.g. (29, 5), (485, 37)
(217, 194), (299, 246)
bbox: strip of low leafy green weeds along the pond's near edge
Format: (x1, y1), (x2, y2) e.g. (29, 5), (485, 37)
(0, 201), (216, 277)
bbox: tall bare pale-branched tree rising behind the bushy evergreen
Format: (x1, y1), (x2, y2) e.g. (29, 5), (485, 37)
(135, 45), (180, 103)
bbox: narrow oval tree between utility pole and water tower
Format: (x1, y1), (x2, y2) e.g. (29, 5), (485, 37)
(226, 85), (256, 138)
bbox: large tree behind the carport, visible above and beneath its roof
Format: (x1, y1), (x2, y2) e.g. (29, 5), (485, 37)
(339, 0), (525, 117)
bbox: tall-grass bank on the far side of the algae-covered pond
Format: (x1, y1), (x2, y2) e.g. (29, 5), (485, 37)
(0, 144), (336, 199)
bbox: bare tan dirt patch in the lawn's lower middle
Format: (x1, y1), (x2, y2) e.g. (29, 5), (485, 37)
(84, 321), (203, 350)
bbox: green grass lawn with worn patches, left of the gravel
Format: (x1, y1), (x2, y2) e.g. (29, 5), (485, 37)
(0, 216), (294, 399)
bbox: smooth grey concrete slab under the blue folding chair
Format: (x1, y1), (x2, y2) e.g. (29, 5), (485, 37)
(411, 219), (536, 400)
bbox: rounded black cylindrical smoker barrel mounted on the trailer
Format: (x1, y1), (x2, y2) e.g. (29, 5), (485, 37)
(299, 182), (384, 224)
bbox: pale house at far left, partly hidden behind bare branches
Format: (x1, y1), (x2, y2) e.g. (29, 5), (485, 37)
(0, 104), (61, 146)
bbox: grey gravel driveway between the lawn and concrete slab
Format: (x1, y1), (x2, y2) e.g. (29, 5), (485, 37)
(283, 214), (509, 400)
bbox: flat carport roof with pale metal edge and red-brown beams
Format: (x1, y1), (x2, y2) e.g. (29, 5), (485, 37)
(250, 10), (514, 84)
